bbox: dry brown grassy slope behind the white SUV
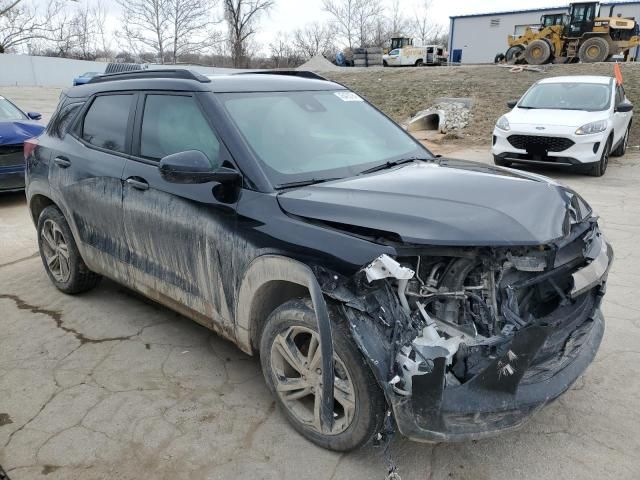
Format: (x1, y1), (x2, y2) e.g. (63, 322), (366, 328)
(322, 63), (640, 145)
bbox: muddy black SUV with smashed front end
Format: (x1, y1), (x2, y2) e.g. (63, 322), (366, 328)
(25, 70), (613, 450)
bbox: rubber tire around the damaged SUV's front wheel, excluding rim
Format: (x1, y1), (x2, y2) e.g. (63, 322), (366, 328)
(260, 298), (386, 452)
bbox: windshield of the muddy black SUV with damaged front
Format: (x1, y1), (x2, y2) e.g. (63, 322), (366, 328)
(219, 90), (432, 185)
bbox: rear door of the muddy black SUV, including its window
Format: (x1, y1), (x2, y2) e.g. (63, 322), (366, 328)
(47, 93), (136, 283)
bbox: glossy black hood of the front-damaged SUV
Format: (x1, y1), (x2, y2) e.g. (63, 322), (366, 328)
(278, 160), (590, 246)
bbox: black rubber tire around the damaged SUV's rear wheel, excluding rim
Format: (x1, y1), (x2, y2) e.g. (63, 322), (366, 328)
(37, 206), (102, 294)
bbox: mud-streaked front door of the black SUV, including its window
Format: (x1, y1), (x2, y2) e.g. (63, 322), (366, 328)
(123, 92), (235, 334)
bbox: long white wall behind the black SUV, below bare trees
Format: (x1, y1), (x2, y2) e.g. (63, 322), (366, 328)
(0, 54), (245, 87)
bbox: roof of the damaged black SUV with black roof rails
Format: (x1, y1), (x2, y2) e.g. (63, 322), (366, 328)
(66, 70), (346, 98)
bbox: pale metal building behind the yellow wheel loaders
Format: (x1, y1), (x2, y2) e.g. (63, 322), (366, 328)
(449, 1), (640, 63)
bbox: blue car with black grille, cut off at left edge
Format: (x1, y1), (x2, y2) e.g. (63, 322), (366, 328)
(0, 96), (44, 192)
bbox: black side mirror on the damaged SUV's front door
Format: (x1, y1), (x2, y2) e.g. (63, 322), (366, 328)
(158, 150), (240, 184)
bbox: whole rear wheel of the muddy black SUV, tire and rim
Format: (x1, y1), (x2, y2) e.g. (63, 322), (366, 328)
(37, 206), (102, 294)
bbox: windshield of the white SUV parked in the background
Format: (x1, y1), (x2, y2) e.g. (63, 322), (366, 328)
(518, 83), (611, 112)
